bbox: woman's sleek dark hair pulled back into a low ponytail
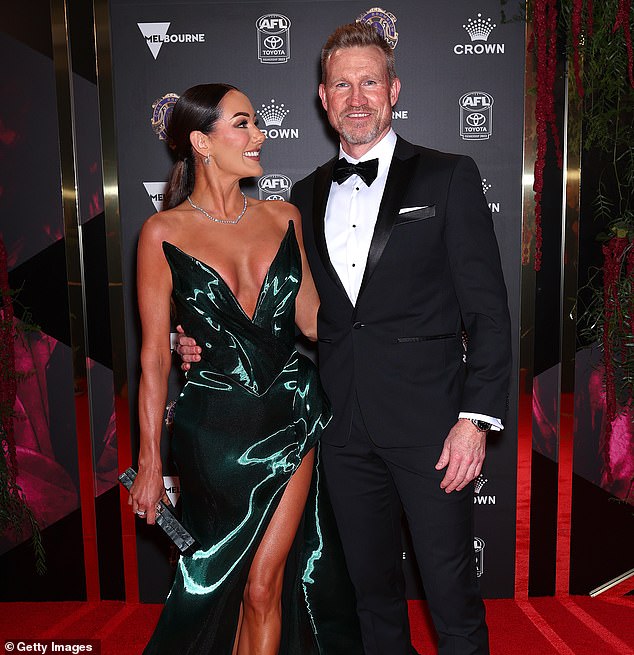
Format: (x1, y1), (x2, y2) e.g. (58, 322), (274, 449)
(163, 84), (237, 209)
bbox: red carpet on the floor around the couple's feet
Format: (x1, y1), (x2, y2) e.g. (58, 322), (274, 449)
(0, 596), (634, 655)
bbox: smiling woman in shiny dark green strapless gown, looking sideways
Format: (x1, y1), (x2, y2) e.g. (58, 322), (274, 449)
(130, 84), (362, 655)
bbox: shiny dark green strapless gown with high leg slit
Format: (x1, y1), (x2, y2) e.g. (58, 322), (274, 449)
(144, 222), (363, 655)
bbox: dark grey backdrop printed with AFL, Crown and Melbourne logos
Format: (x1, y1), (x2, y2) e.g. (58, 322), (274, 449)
(110, 0), (525, 601)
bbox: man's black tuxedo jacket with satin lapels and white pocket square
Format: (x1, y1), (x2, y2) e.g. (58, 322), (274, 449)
(291, 137), (511, 446)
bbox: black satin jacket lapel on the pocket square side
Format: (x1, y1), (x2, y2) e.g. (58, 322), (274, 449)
(357, 145), (418, 304)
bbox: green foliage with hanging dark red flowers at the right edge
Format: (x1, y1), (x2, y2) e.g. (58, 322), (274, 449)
(562, 0), (634, 412)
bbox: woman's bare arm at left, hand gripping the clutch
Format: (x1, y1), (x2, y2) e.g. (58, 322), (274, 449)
(128, 214), (172, 523)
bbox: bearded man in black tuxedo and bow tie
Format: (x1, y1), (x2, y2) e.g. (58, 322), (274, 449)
(291, 23), (511, 655)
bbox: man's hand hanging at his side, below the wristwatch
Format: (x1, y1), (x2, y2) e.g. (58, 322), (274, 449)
(436, 419), (487, 493)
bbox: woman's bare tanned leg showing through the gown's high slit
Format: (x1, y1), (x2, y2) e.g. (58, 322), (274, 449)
(237, 450), (315, 655)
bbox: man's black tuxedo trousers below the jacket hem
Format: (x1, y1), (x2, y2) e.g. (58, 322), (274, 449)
(322, 394), (489, 655)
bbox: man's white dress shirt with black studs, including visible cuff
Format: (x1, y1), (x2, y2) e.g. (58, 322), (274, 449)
(324, 129), (504, 431)
